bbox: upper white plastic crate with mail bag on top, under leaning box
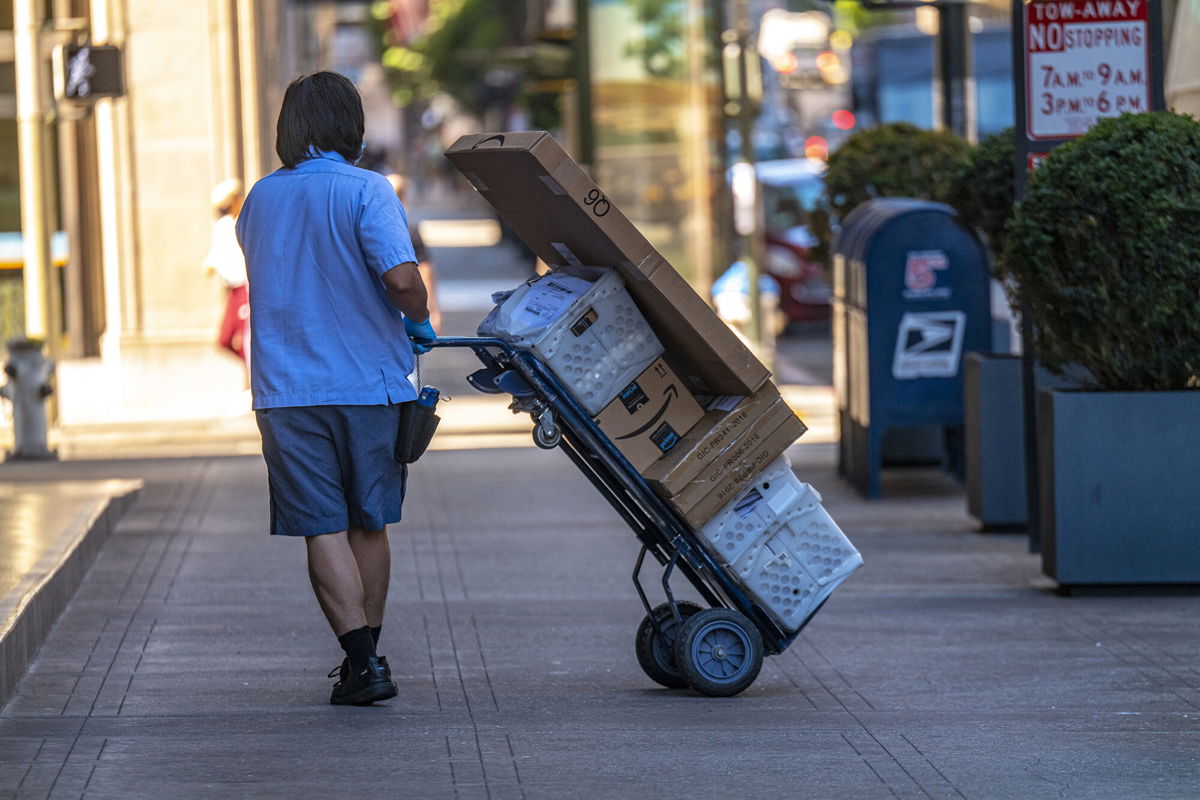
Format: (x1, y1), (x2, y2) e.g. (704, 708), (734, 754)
(479, 267), (662, 416)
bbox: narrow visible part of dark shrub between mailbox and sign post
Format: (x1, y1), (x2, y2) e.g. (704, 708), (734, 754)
(949, 128), (1016, 275)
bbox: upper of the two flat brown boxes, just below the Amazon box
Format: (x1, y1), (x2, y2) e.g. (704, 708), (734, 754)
(644, 384), (808, 498)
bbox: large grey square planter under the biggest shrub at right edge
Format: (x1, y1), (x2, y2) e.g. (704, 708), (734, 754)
(1038, 390), (1200, 587)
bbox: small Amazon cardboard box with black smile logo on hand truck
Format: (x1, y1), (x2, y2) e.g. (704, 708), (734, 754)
(595, 359), (704, 473)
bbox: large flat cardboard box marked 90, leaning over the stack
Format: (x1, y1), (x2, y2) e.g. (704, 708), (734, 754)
(445, 132), (770, 395)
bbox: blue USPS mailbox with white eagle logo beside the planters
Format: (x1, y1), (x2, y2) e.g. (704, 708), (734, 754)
(833, 198), (991, 498)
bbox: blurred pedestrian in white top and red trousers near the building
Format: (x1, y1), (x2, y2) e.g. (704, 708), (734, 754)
(204, 178), (250, 385)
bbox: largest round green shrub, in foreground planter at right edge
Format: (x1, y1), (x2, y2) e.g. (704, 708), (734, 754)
(1003, 112), (1200, 391)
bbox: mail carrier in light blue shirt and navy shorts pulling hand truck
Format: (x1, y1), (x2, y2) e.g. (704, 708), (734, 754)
(236, 72), (436, 705)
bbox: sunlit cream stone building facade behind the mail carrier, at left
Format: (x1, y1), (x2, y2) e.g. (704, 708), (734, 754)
(0, 0), (348, 426)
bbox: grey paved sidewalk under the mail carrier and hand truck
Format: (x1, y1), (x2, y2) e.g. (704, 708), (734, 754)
(0, 445), (1200, 800)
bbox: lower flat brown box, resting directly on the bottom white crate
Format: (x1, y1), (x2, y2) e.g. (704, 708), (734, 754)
(671, 409), (805, 528)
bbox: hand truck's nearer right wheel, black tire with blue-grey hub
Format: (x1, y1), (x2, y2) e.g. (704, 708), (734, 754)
(676, 608), (763, 697)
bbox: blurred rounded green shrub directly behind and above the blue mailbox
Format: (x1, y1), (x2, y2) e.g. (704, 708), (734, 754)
(812, 122), (971, 263)
